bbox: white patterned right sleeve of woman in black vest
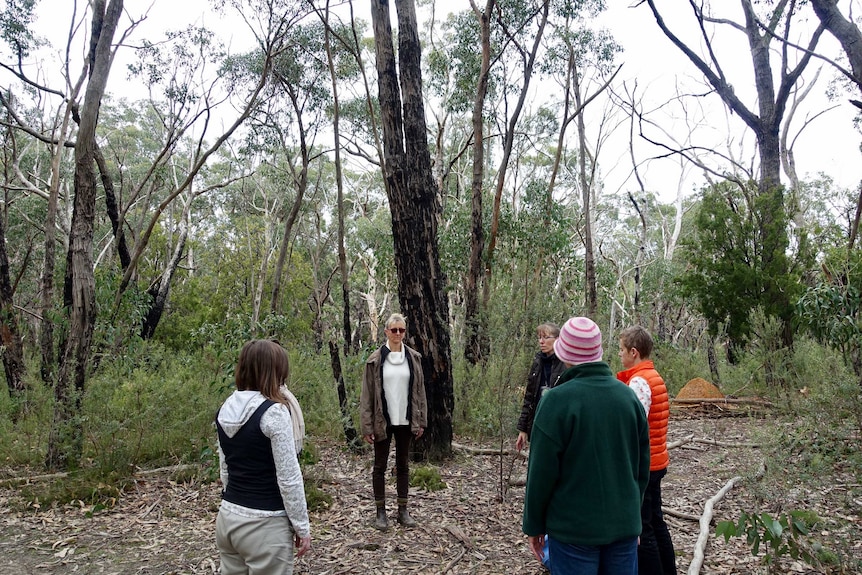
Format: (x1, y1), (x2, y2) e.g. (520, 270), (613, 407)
(260, 403), (310, 537)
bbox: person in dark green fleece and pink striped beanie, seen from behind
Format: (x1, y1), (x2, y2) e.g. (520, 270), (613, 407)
(522, 317), (650, 575)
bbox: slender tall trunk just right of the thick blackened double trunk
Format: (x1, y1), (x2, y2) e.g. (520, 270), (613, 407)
(464, 0), (495, 365)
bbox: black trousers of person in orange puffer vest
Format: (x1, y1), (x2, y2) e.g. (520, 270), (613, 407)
(638, 469), (676, 575)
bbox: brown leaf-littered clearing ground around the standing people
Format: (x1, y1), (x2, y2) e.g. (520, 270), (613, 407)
(0, 412), (862, 575)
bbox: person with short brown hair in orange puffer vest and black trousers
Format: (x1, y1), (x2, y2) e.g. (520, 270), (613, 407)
(617, 325), (676, 575)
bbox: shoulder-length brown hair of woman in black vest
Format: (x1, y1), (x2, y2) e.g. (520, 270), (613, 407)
(234, 339), (290, 404)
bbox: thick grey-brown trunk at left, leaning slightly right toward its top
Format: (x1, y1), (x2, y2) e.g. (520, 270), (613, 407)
(46, 0), (123, 469)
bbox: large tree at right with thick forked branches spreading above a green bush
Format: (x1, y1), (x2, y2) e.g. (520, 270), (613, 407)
(646, 0), (825, 352)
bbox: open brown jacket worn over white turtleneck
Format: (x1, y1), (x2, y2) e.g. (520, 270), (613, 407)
(359, 344), (428, 441)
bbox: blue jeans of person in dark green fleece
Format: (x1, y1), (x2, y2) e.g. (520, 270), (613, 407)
(549, 537), (638, 575)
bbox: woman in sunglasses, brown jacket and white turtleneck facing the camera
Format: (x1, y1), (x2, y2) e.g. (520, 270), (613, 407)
(359, 314), (428, 531)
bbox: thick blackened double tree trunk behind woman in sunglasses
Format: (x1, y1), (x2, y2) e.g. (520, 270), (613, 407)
(371, 0), (455, 458)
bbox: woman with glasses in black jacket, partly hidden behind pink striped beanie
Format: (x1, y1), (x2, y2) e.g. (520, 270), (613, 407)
(515, 323), (565, 451)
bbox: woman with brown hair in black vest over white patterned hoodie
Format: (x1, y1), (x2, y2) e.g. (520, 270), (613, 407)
(216, 339), (311, 575)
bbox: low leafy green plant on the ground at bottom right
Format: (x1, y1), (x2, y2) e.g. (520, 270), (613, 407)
(715, 511), (820, 571)
